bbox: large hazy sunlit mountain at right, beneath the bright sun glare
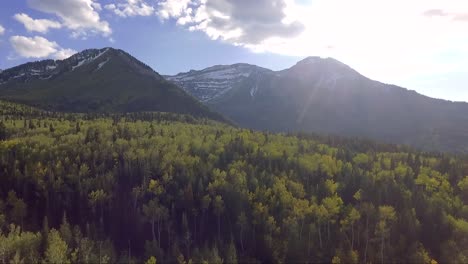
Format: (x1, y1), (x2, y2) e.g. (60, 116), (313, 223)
(168, 57), (468, 152)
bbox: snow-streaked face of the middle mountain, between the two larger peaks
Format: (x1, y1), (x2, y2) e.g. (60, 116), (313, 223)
(165, 63), (269, 102)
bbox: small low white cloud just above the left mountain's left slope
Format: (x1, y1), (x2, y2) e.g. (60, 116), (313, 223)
(10, 36), (75, 59)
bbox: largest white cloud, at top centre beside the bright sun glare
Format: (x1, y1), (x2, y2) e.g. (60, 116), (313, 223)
(157, 0), (304, 45)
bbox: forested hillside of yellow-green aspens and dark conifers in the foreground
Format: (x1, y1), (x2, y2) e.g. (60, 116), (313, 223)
(0, 102), (468, 263)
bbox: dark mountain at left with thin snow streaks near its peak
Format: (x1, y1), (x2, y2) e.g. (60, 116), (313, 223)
(0, 48), (222, 120)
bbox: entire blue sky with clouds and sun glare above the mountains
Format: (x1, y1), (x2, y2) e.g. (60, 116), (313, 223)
(0, 0), (468, 102)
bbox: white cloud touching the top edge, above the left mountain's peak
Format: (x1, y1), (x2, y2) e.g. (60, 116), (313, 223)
(29, 0), (112, 37)
